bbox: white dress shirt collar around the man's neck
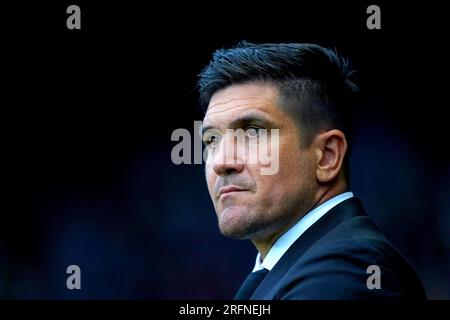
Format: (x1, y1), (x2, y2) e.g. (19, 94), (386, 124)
(252, 192), (353, 272)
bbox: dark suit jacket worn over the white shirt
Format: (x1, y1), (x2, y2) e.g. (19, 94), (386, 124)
(246, 198), (426, 300)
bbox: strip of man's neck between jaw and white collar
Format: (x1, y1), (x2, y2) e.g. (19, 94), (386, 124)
(251, 180), (347, 260)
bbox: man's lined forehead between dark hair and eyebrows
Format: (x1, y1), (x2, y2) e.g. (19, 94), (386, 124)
(204, 84), (284, 126)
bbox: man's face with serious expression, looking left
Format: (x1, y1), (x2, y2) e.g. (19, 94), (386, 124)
(203, 84), (317, 239)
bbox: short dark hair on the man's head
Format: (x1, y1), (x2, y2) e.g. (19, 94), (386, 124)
(198, 41), (358, 177)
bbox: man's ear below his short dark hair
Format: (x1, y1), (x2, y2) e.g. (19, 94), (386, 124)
(315, 129), (347, 183)
